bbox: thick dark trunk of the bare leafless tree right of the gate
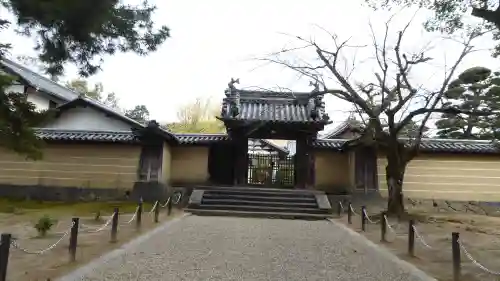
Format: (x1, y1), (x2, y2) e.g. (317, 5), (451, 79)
(385, 157), (406, 216)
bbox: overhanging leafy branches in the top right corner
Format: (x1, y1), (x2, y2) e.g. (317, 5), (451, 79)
(365, 0), (500, 57)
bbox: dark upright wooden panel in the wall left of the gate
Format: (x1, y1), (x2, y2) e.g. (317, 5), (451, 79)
(138, 145), (163, 181)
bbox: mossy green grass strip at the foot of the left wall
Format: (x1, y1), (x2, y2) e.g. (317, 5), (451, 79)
(0, 198), (152, 216)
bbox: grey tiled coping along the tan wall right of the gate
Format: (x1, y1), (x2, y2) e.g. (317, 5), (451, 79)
(313, 138), (500, 154)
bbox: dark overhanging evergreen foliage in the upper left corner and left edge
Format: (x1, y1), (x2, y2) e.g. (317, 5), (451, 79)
(0, 0), (169, 158)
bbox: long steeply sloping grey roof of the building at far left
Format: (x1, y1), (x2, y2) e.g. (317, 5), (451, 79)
(0, 57), (78, 102)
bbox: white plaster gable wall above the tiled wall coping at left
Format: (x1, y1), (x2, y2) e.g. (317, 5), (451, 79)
(45, 107), (130, 131)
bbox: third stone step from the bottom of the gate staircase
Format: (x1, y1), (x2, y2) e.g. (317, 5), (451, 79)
(201, 197), (318, 208)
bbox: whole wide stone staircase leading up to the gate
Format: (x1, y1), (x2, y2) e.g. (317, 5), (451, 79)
(185, 187), (331, 219)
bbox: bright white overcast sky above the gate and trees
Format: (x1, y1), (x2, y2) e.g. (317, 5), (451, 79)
(0, 0), (500, 126)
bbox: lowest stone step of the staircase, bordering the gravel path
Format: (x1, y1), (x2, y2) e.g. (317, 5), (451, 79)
(184, 208), (331, 220)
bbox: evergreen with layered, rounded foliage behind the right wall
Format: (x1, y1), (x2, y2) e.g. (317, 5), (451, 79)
(436, 67), (500, 139)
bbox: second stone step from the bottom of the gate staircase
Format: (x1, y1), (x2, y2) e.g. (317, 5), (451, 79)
(190, 204), (328, 214)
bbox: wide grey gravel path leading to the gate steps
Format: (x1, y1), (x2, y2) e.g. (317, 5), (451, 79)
(56, 216), (432, 281)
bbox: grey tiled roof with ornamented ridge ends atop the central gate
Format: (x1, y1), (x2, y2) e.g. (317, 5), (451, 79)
(220, 81), (329, 124)
